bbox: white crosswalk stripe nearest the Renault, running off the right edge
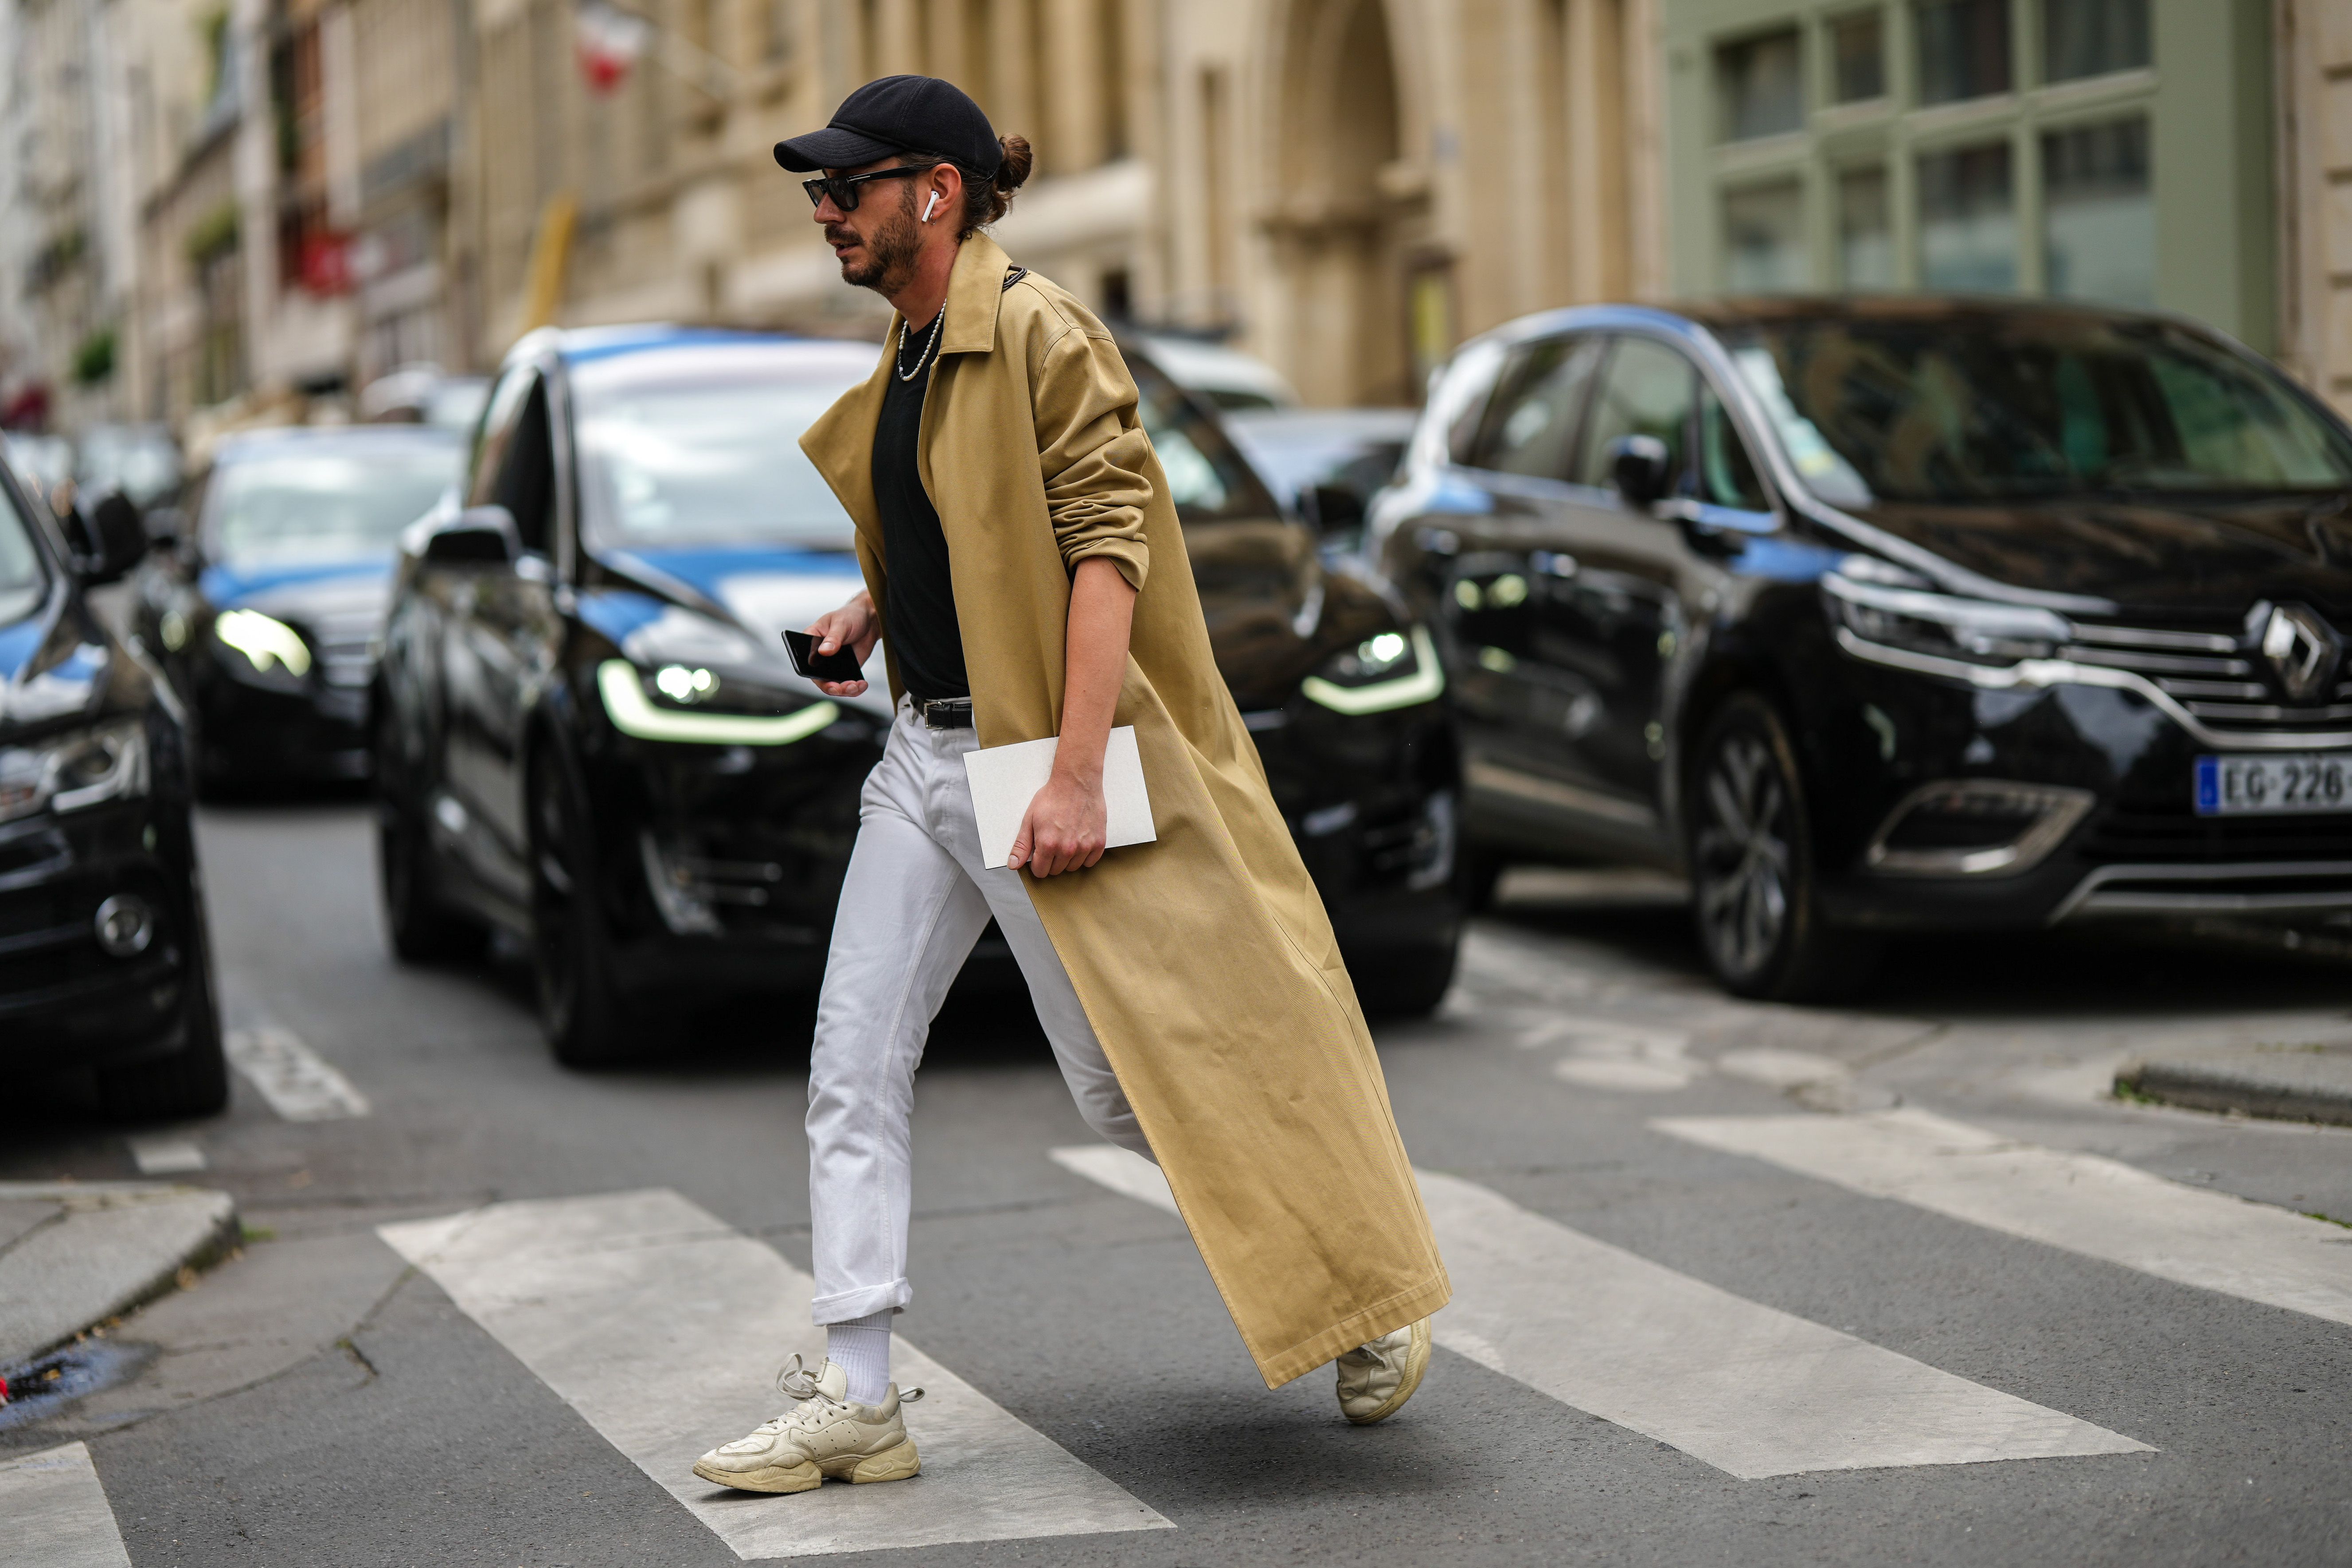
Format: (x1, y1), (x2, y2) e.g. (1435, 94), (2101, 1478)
(1651, 1107), (2352, 1324)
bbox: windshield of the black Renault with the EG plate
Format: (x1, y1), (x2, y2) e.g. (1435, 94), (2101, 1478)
(1719, 313), (2352, 505)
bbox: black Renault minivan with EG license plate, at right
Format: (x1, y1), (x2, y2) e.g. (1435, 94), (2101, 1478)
(1367, 298), (2352, 997)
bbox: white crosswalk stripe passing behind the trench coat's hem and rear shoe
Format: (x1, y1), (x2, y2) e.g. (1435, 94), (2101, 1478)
(1051, 1145), (2147, 1478)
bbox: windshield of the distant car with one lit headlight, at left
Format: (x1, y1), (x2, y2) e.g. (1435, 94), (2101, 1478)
(205, 437), (463, 559)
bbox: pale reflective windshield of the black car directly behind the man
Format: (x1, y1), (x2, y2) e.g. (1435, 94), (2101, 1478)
(571, 350), (873, 548)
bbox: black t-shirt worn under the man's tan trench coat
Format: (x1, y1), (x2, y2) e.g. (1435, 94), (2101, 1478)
(875, 332), (971, 698)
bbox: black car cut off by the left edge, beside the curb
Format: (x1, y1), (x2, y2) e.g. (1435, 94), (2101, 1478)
(0, 463), (228, 1119)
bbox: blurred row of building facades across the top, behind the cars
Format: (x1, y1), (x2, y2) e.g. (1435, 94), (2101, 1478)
(0, 0), (2352, 433)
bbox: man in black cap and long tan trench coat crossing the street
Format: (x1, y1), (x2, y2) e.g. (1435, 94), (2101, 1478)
(694, 75), (1449, 1493)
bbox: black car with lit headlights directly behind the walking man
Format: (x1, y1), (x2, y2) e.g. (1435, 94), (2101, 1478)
(371, 327), (1461, 1063)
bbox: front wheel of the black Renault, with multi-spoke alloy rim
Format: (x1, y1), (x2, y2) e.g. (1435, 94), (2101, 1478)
(1684, 691), (1877, 1001)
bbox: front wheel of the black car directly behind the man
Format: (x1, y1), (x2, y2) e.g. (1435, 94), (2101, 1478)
(531, 750), (637, 1067)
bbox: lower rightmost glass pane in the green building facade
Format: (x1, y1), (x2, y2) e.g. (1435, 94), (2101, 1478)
(2042, 120), (2157, 305)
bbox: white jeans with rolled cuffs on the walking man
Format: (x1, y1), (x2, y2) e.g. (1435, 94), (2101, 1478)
(809, 700), (1153, 1324)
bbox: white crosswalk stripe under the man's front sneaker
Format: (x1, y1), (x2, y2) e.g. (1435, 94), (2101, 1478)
(376, 1189), (1171, 1559)
